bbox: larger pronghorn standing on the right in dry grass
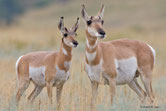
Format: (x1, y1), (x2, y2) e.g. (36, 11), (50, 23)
(81, 5), (155, 108)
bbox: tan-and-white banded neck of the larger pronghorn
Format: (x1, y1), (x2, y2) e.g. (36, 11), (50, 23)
(86, 31), (101, 65)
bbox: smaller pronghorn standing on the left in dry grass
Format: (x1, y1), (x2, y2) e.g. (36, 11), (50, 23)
(16, 17), (79, 108)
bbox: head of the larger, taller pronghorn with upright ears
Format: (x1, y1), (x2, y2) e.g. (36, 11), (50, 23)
(81, 5), (106, 38)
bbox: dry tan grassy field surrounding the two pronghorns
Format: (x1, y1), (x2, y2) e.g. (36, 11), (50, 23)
(0, 0), (166, 111)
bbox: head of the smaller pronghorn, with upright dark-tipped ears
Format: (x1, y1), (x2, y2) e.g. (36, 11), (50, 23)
(58, 17), (79, 47)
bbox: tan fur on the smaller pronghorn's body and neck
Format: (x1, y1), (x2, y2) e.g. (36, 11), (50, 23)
(17, 43), (72, 103)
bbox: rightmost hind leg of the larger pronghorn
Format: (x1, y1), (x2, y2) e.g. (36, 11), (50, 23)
(141, 74), (154, 103)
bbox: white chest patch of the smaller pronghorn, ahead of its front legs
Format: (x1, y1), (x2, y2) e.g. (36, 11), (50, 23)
(55, 65), (70, 81)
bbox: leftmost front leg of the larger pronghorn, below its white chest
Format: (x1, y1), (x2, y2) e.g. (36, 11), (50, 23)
(91, 81), (99, 111)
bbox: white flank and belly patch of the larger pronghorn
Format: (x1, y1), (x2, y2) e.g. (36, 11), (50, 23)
(115, 57), (138, 85)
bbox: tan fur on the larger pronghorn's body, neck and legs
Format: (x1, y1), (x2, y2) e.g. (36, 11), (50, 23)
(86, 31), (154, 106)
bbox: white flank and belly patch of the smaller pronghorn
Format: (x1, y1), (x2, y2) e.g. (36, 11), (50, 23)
(29, 66), (46, 86)
